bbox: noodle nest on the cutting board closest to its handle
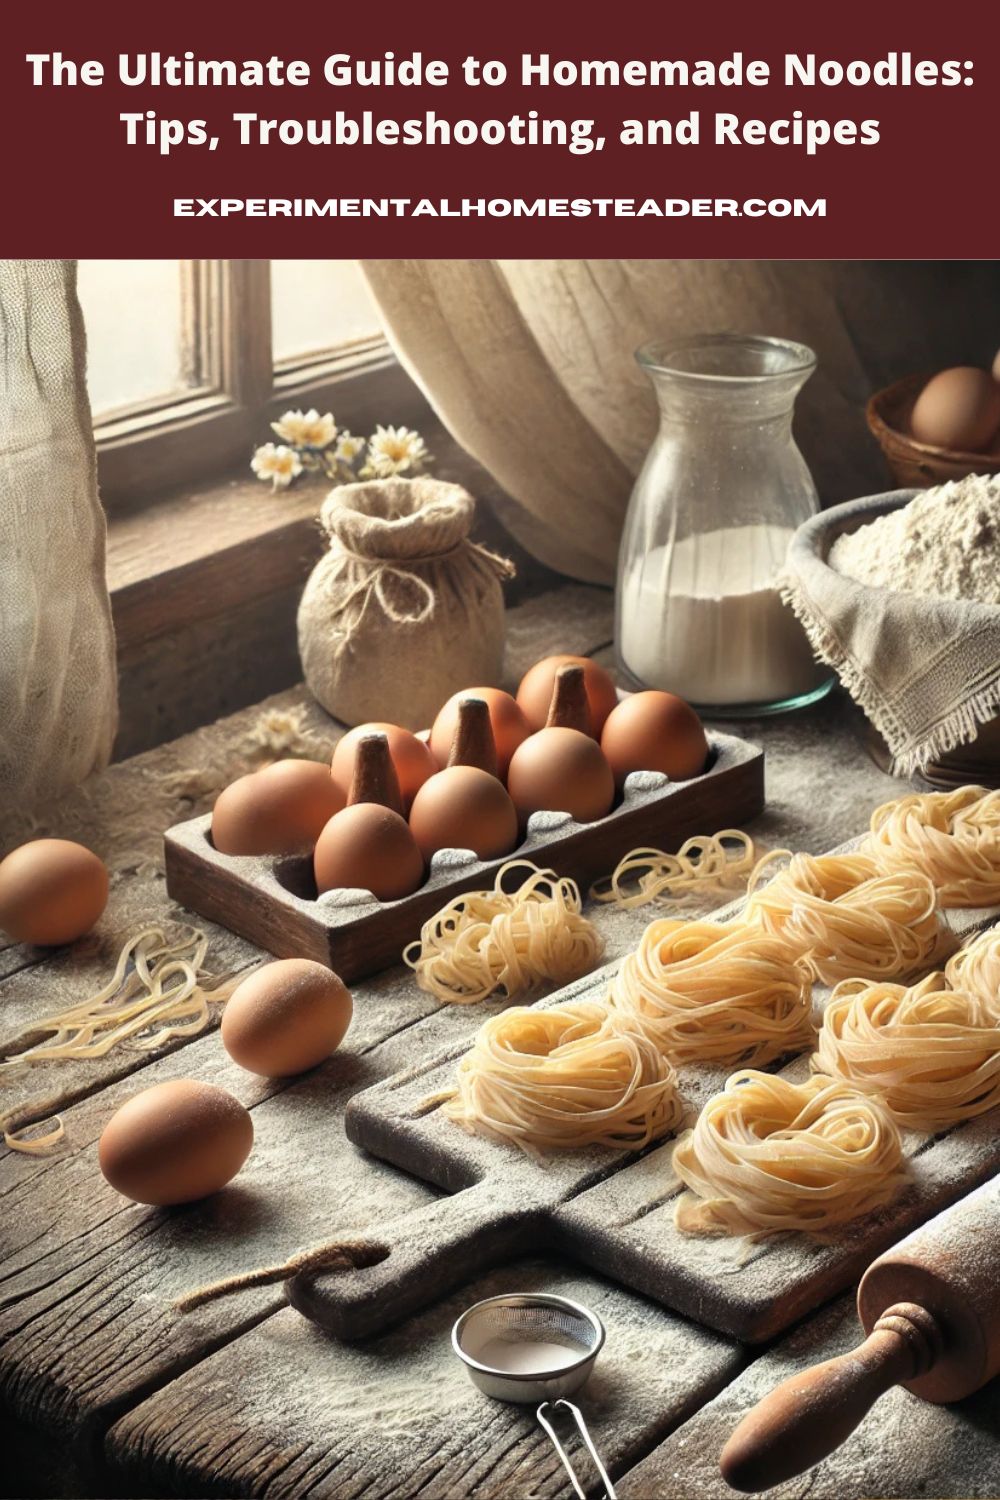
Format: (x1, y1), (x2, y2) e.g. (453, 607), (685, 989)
(444, 1001), (682, 1157)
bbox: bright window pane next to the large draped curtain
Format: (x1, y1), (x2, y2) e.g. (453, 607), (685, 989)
(271, 261), (379, 363)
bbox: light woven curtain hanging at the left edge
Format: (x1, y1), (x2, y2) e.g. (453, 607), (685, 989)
(0, 261), (117, 822)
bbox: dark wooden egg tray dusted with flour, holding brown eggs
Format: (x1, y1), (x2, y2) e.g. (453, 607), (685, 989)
(165, 734), (765, 981)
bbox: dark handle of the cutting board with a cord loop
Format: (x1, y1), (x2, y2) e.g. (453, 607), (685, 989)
(285, 1181), (544, 1340)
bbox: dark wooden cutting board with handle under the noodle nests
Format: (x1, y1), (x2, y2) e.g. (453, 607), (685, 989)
(289, 888), (1000, 1343)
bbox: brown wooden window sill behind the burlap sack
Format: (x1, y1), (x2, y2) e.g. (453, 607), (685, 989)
(108, 420), (555, 759)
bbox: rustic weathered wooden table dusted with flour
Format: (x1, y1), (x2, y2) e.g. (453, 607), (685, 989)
(0, 587), (1000, 1500)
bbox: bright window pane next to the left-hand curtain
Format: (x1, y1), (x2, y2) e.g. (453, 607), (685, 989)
(78, 261), (189, 419)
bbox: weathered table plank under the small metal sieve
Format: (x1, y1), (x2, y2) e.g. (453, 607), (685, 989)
(106, 1260), (741, 1500)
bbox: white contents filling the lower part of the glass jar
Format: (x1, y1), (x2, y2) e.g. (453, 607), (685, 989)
(619, 525), (829, 708)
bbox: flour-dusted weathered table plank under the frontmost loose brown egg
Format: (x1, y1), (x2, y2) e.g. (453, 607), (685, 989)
(0, 972), (446, 1482)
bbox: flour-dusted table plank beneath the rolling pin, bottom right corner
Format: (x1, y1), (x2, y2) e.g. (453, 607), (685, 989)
(618, 1296), (1000, 1500)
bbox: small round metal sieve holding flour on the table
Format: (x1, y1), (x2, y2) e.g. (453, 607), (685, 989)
(451, 1292), (615, 1500)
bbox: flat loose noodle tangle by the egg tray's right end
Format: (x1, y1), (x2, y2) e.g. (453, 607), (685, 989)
(591, 828), (754, 909)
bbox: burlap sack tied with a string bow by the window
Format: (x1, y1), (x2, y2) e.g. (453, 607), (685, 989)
(298, 479), (514, 729)
